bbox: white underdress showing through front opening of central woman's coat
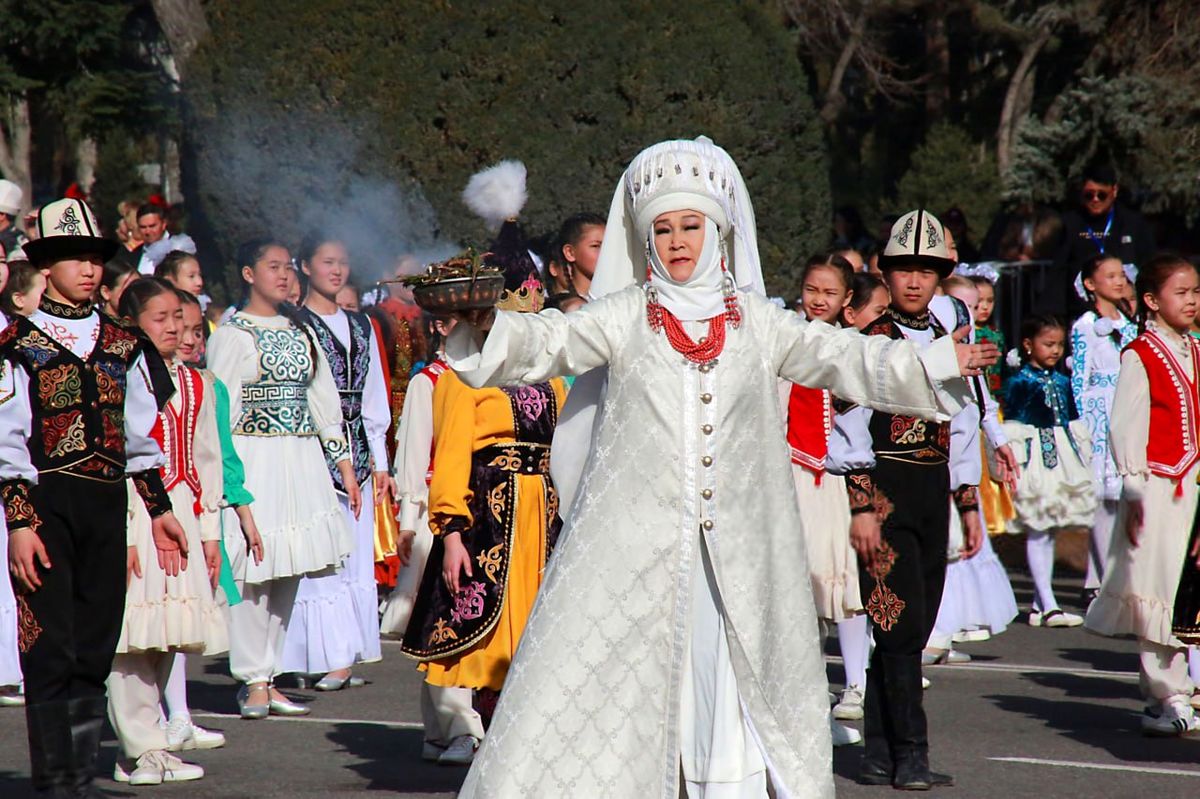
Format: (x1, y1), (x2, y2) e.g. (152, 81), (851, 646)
(679, 537), (767, 799)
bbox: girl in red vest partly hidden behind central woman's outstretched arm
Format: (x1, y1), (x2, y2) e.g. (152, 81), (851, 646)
(782, 254), (870, 729)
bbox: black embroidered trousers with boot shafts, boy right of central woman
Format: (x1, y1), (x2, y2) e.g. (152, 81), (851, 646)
(859, 458), (950, 777)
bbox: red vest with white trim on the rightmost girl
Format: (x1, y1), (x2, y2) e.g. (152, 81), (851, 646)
(1127, 330), (1200, 493)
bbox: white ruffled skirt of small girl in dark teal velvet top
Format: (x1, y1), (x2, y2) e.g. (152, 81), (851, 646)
(1004, 420), (1097, 530)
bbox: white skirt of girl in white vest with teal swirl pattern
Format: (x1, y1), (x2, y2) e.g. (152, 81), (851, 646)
(233, 435), (354, 583)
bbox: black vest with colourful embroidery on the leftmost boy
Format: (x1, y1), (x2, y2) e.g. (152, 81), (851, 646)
(0, 313), (140, 482)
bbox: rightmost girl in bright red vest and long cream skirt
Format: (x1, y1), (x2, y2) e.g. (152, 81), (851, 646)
(1087, 256), (1200, 735)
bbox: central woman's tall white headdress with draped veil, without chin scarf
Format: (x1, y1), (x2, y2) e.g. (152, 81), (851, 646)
(588, 136), (766, 300)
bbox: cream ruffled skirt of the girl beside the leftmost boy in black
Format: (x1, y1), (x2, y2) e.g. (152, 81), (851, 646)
(116, 482), (229, 655)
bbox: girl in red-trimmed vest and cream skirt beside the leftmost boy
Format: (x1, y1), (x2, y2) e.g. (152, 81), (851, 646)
(108, 278), (228, 785)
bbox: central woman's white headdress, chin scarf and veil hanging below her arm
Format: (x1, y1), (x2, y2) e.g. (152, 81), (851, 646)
(551, 136), (766, 517)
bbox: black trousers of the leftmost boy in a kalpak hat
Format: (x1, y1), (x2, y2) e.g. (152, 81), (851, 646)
(18, 474), (127, 705)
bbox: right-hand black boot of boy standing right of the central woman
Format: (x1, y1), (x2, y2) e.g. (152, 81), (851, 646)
(883, 654), (934, 791)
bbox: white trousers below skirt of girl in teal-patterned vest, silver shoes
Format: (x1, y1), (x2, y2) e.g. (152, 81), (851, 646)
(229, 577), (300, 685)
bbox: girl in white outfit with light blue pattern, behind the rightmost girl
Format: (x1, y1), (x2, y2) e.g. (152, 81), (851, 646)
(1070, 253), (1138, 600)
